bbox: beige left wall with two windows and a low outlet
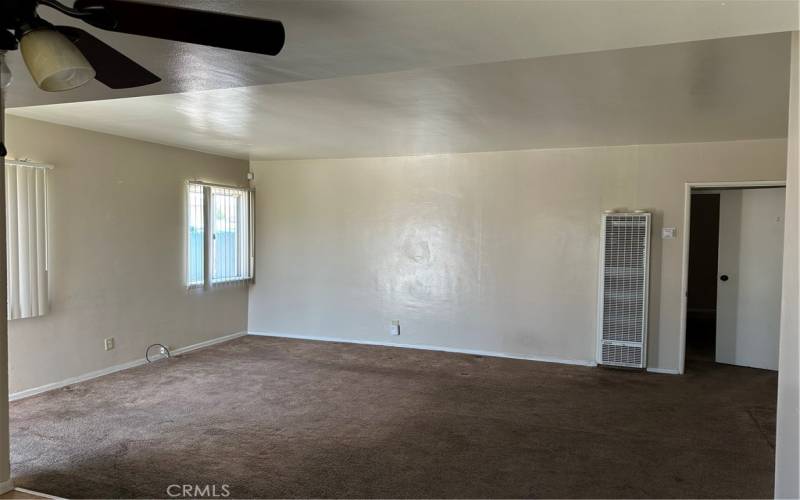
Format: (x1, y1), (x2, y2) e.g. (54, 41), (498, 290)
(7, 116), (248, 393)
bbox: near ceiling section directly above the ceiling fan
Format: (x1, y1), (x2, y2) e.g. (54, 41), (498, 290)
(7, 0), (800, 107)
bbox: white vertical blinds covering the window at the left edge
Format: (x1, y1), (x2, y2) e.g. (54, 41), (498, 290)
(5, 163), (49, 319)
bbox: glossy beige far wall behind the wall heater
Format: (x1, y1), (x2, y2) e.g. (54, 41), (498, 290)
(248, 139), (786, 370)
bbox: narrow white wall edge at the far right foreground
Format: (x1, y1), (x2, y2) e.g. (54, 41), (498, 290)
(775, 32), (800, 498)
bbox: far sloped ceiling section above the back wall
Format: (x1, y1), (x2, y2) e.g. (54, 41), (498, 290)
(11, 33), (789, 159)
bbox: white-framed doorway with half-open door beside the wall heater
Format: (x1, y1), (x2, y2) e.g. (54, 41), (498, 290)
(681, 182), (785, 372)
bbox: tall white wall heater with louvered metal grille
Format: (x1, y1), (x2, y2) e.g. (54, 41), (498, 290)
(597, 213), (650, 368)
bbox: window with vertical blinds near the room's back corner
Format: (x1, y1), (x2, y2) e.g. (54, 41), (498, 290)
(186, 183), (253, 287)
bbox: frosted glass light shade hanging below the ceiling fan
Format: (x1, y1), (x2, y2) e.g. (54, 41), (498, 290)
(20, 29), (95, 92)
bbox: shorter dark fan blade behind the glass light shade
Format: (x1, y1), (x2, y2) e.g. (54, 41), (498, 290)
(56, 26), (161, 89)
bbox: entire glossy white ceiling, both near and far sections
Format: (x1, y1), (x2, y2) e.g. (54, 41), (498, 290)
(8, 0), (800, 159)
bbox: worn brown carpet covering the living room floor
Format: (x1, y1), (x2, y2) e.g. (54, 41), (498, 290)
(11, 337), (777, 498)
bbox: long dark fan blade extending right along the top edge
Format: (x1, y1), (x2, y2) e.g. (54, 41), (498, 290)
(75, 0), (286, 56)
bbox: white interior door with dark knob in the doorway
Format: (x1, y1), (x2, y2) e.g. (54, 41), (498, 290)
(716, 188), (786, 370)
